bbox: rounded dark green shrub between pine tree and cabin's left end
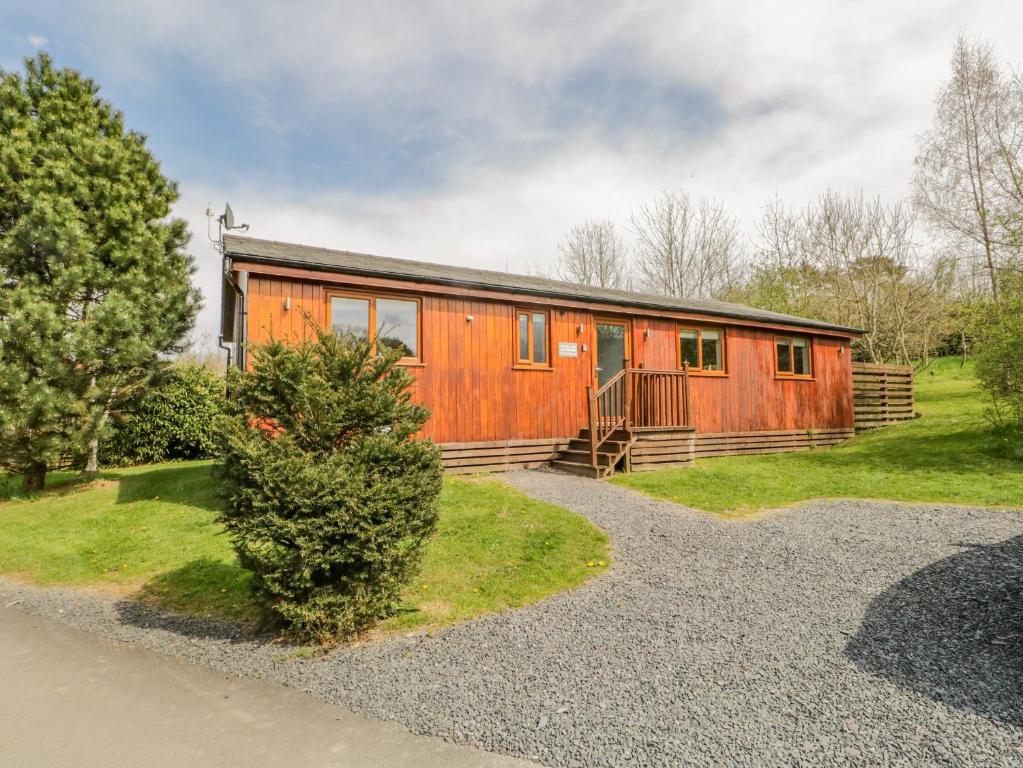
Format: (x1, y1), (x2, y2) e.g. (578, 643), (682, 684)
(99, 364), (224, 466)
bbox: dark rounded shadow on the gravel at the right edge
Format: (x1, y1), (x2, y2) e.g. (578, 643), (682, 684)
(846, 536), (1023, 726)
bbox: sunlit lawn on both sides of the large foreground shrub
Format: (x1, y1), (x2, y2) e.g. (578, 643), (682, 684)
(0, 462), (609, 631)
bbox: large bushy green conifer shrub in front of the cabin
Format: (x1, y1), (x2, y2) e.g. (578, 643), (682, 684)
(219, 331), (441, 642)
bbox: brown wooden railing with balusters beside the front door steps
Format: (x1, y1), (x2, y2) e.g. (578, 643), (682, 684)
(588, 366), (690, 466)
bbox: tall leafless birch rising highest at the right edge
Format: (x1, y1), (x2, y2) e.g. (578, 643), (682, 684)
(916, 37), (1023, 303)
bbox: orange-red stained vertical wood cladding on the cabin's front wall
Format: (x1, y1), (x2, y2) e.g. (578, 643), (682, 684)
(247, 273), (854, 444)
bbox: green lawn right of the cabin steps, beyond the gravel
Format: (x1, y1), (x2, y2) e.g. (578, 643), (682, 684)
(613, 358), (1023, 513)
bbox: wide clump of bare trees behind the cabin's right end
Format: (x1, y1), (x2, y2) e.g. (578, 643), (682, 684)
(729, 192), (952, 362)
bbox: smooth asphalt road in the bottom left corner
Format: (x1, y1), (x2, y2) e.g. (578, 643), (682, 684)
(0, 607), (529, 768)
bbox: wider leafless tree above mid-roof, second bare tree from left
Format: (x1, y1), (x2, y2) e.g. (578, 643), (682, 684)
(631, 192), (742, 299)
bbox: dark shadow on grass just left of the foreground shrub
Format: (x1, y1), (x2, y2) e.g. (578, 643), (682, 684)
(117, 557), (272, 642)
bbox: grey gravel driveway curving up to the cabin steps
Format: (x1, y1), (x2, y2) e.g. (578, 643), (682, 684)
(0, 471), (1023, 766)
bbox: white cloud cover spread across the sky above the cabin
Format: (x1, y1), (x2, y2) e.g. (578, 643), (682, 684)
(94, 0), (1023, 347)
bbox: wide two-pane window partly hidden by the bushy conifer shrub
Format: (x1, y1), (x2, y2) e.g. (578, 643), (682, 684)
(330, 296), (420, 362)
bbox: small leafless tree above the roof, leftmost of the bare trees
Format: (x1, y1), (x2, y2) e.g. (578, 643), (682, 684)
(550, 219), (630, 289)
